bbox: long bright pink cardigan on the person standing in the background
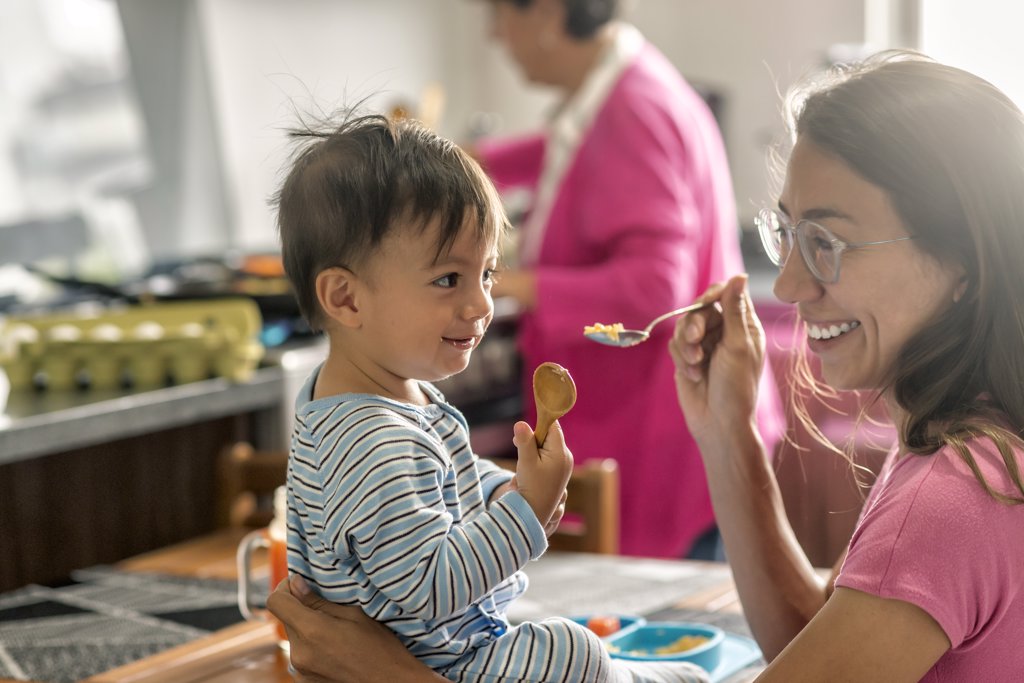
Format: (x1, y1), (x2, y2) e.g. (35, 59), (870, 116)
(479, 44), (782, 557)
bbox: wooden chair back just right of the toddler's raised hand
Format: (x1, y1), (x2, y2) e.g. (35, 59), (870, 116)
(495, 458), (618, 555)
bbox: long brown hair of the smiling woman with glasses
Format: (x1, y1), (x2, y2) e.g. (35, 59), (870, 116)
(790, 51), (1024, 504)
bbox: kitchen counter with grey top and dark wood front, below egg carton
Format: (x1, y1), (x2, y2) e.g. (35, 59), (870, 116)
(0, 353), (302, 590)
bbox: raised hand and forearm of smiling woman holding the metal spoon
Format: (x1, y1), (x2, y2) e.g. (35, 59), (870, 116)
(670, 276), (827, 661)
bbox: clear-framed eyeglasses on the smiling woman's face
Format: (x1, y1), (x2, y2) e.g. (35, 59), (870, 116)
(754, 209), (913, 285)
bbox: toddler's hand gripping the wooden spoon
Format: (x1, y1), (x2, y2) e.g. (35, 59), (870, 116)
(512, 421), (572, 536)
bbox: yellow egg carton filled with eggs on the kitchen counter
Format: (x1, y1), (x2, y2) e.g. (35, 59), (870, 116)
(0, 298), (263, 390)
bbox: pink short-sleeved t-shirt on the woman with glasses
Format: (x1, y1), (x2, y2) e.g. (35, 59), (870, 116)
(836, 439), (1024, 682)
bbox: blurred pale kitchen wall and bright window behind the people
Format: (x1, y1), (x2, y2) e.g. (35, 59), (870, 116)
(0, 0), (1024, 286)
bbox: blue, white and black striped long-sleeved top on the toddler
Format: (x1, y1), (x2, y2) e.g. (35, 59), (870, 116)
(288, 373), (547, 670)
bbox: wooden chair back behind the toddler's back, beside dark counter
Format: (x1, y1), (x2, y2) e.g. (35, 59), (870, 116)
(216, 441), (288, 527)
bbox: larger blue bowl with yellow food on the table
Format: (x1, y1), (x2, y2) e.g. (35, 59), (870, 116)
(604, 622), (725, 671)
